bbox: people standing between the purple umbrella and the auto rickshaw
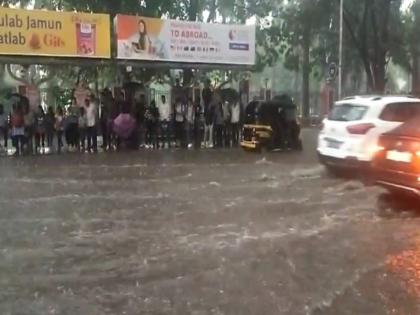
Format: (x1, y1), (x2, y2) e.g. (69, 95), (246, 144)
(138, 84), (243, 148)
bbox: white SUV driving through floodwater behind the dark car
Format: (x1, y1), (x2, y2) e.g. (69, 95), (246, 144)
(318, 96), (420, 169)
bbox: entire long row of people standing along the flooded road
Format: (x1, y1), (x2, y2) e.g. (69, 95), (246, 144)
(0, 82), (246, 155)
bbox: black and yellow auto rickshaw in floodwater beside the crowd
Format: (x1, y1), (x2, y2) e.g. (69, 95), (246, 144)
(241, 95), (302, 152)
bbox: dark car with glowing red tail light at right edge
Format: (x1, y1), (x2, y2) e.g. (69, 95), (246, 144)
(372, 117), (420, 197)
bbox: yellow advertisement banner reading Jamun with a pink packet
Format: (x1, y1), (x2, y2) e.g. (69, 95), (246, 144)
(0, 7), (111, 58)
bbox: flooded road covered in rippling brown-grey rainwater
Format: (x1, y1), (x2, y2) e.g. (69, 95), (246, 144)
(0, 131), (420, 315)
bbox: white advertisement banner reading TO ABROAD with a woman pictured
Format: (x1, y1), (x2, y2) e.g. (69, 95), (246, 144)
(115, 15), (255, 65)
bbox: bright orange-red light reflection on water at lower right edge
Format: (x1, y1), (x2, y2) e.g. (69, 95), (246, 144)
(386, 236), (420, 299)
